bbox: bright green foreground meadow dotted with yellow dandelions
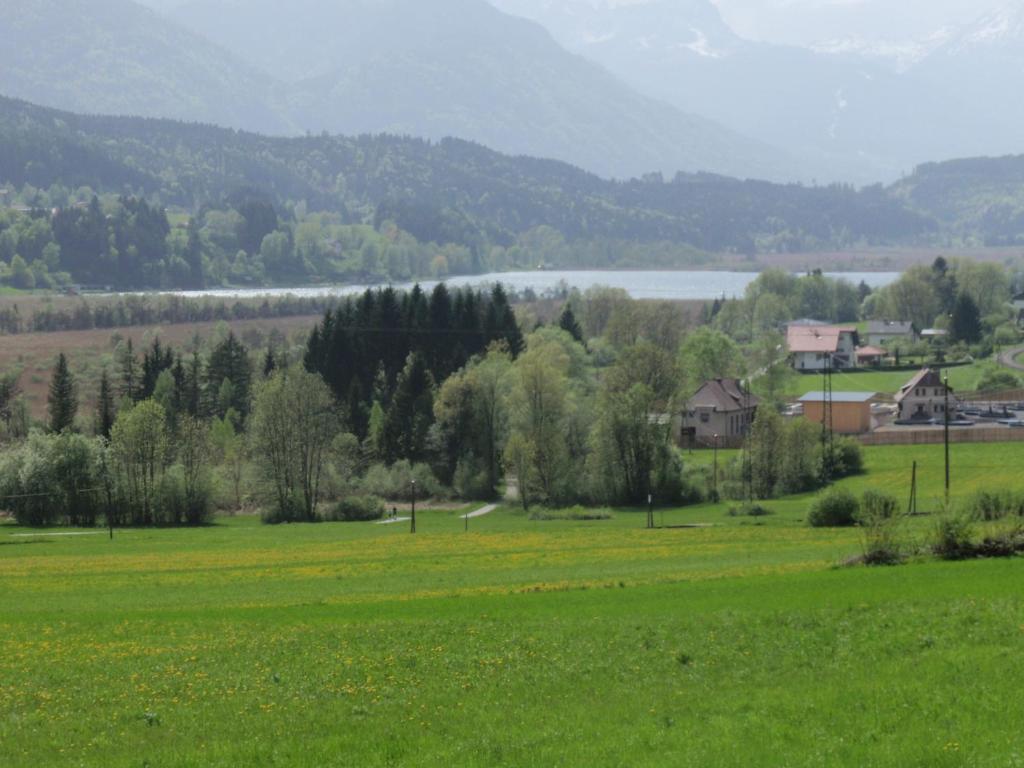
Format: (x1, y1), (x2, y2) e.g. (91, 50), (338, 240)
(0, 444), (1024, 768)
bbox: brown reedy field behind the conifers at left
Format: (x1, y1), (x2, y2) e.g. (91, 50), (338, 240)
(0, 314), (321, 418)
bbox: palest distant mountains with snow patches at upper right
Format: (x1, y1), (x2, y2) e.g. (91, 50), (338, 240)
(493, 0), (1024, 183)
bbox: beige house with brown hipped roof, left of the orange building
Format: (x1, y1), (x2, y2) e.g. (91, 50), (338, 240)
(681, 379), (759, 446)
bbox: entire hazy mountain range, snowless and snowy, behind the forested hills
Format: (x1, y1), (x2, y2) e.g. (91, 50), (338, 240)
(0, 0), (1024, 184)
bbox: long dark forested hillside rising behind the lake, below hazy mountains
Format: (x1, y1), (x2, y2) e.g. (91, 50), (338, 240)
(0, 99), (937, 286)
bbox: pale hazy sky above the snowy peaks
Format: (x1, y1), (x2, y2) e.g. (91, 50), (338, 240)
(716, 0), (1011, 45)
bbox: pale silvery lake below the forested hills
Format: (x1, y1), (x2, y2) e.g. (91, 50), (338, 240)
(151, 269), (900, 300)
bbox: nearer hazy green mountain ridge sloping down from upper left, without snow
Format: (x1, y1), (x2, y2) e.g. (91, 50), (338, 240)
(0, 0), (808, 185)
